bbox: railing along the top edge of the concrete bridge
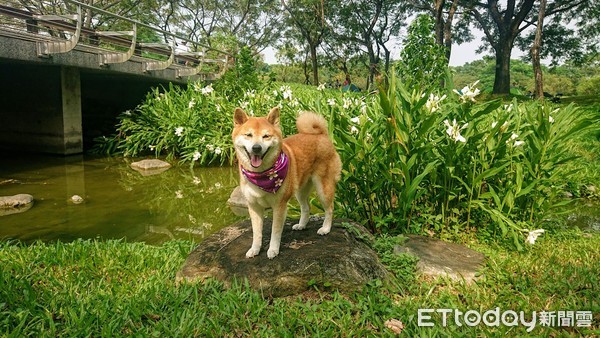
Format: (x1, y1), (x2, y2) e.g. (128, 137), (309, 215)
(0, 0), (229, 78)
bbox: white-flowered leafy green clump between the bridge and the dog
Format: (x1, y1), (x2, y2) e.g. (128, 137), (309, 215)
(97, 83), (233, 164)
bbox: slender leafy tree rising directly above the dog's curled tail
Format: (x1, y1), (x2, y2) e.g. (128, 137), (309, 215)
(281, 0), (331, 85)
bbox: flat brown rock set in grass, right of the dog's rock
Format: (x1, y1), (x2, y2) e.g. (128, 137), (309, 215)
(394, 235), (485, 284)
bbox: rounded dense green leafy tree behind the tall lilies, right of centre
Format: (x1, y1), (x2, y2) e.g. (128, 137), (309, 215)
(397, 14), (448, 92)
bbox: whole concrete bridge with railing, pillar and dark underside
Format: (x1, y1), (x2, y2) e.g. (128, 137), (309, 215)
(0, 0), (228, 155)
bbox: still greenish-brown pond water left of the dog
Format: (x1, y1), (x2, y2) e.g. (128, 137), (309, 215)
(0, 155), (241, 244)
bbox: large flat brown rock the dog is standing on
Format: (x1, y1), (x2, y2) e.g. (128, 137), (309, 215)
(177, 219), (388, 297)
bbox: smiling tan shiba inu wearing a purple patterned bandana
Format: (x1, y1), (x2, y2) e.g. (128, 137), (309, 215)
(232, 108), (342, 259)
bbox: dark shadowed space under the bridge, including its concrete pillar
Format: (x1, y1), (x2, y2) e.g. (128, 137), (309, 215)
(0, 59), (176, 155)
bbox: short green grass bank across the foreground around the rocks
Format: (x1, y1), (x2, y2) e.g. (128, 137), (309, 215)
(0, 230), (600, 337)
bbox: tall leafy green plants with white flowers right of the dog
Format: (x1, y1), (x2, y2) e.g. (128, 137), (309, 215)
(333, 70), (598, 247)
